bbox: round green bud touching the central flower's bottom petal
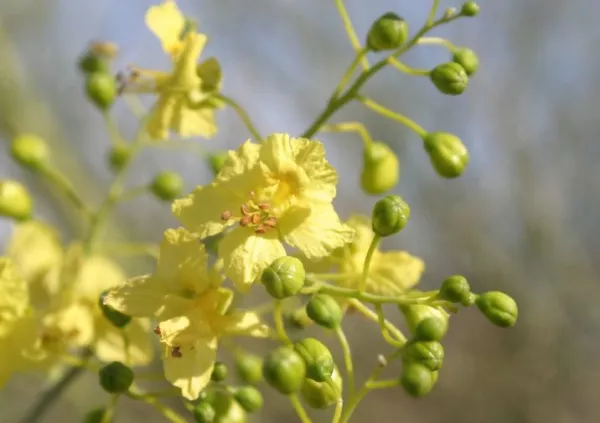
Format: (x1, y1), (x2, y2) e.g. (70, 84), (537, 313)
(261, 256), (306, 300)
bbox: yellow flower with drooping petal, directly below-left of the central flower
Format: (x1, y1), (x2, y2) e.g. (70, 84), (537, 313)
(105, 228), (268, 400)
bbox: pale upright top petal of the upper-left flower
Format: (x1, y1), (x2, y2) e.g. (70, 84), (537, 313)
(146, 0), (185, 55)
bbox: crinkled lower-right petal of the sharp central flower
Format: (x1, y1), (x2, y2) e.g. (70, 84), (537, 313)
(277, 204), (354, 259)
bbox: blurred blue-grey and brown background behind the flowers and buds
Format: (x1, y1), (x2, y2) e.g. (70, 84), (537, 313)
(0, 0), (600, 423)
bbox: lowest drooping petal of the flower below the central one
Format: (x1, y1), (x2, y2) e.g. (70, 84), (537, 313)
(163, 338), (217, 401)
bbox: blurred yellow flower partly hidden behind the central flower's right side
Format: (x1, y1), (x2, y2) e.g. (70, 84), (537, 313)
(304, 215), (425, 295)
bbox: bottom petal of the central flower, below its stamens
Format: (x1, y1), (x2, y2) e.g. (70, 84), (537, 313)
(219, 227), (286, 292)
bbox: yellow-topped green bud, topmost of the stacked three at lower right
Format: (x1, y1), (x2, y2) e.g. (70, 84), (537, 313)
(400, 304), (448, 341)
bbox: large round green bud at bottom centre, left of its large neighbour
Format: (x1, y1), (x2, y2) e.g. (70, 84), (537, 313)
(263, 347), (306, 395)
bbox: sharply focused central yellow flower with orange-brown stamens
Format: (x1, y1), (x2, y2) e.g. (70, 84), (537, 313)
(173, 134), (354, 291)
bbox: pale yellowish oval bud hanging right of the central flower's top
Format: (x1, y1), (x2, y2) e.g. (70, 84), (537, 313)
(360, 142), (400, 194)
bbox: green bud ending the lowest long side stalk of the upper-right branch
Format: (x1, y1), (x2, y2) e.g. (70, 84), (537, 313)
(423, 132), (469, 178)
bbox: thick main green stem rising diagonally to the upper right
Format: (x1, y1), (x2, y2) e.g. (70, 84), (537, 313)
(301, 14), (461, 138)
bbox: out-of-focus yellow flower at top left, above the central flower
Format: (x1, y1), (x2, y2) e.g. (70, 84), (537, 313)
(125, 1), (222, 140)
